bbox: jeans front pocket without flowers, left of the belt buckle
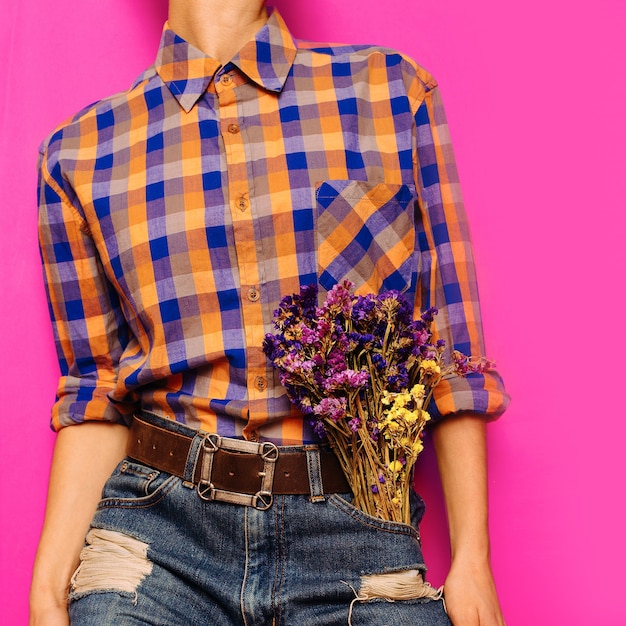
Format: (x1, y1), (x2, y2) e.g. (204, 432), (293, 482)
(98, 459), (179, 508)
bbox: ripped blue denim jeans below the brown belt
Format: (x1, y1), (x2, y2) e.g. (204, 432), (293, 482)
(69, 416), (450, 626)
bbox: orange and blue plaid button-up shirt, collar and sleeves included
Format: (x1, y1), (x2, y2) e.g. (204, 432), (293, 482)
(40, 11), (508, 444)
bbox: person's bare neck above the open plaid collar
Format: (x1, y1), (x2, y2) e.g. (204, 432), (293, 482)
(168, 0), (267, 64)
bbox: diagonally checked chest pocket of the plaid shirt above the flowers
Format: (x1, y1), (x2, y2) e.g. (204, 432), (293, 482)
(315, 180), (417, 293)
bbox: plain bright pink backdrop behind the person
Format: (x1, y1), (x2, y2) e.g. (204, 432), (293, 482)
(0, 0), (626, 626)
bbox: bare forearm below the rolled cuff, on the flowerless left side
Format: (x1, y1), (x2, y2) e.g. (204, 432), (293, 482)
(30, 422), (128, 626)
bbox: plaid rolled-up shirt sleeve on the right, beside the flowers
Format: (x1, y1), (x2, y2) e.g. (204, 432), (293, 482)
(414, 81), (510, 420)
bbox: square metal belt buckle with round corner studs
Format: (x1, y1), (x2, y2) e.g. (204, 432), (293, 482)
(197, 434), (279, 511)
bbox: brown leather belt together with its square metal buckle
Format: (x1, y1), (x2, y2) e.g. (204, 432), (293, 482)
(127, 416), (350, 509)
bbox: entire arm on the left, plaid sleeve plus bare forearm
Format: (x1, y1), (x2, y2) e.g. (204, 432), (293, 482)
(35, 111), (135, 626)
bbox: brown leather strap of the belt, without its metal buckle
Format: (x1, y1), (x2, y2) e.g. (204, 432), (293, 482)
(127, 417), (350, 495)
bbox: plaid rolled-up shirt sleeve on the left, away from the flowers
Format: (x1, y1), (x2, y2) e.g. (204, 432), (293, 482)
(38, 145), (128, 430)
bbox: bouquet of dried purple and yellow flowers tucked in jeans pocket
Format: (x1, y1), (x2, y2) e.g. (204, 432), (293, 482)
(263, 281), (489, 524)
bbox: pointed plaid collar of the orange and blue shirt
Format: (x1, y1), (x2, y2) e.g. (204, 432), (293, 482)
(155, 9), (297, 112)
